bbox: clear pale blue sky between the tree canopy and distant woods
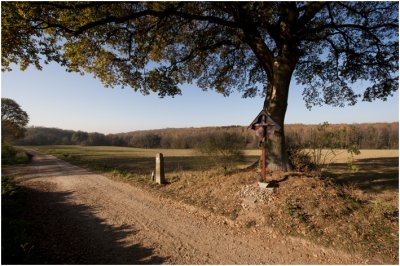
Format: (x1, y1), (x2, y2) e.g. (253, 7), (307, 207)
(1, 64), (399, 133)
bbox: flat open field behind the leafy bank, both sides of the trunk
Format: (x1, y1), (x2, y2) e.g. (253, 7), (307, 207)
(22, 145), (399, 194)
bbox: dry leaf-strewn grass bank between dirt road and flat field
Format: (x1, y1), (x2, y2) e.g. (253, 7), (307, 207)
(131, 167), (399, 264)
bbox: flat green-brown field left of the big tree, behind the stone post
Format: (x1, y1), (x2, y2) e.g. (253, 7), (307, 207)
(25, 146), (258, 175)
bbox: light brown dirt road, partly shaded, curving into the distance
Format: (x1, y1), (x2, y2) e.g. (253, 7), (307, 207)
(3, 154), (372, 264)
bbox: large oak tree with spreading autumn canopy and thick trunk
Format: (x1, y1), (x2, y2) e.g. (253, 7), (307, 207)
(1, 1), (398, 170)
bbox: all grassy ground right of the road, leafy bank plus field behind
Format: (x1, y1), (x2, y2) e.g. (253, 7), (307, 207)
(17, 146), (399, 264)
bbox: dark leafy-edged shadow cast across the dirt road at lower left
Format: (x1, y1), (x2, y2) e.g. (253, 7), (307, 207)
(18, 185), (167, 264)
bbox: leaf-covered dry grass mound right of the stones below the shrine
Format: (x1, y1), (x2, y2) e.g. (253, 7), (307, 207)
(263, 176), (399, 263)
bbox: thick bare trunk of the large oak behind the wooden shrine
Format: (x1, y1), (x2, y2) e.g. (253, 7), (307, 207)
(264, 56), (295, 172)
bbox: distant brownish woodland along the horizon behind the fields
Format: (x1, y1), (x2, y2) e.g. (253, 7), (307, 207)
(17, 122), (399, 149)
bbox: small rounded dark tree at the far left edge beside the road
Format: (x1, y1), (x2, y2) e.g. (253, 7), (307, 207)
(1, 98), (29, 142)
